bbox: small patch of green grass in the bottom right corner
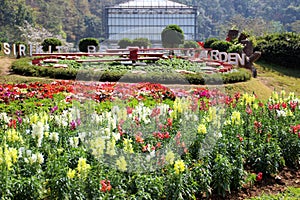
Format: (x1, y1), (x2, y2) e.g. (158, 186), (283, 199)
(251, 187), (300, 200)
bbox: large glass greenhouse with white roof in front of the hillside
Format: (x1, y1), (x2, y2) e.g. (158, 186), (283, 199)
(104, 0), (197, 43)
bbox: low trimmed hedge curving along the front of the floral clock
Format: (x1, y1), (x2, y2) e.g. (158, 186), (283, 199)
(11, 58), (251, 85)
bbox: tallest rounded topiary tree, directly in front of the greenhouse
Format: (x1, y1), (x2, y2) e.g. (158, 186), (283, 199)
(161, 24), (184, 48)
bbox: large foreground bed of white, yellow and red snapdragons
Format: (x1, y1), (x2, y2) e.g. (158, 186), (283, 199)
(0, 81), (300, 199)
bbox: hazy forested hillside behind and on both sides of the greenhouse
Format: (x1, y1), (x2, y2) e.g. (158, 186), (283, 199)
(0, 0), (300, 43)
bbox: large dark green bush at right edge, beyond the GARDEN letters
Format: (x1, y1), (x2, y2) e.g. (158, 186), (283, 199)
(255, 32), (300, 67)
